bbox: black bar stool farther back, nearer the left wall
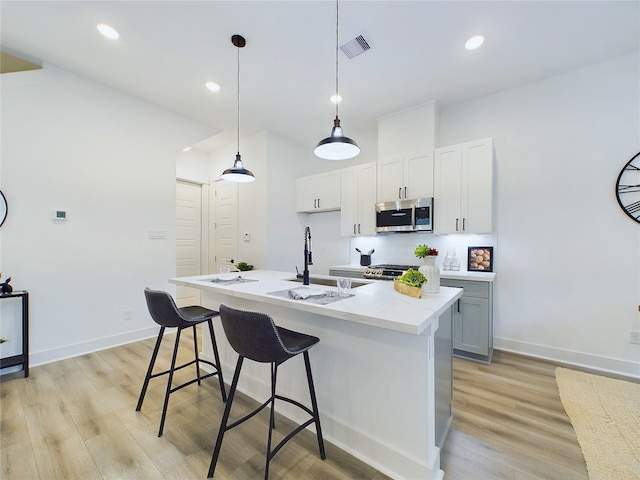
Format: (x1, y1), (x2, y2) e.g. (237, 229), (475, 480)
(136, 288), (227, 437)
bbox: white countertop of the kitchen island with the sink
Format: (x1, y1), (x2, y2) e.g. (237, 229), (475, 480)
(169, 267), (462, 335)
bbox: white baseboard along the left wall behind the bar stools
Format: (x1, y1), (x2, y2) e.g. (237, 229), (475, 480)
(29, 326), (159, 367)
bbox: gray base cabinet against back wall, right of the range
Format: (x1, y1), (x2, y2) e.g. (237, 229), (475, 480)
(440, 278), (493, 363)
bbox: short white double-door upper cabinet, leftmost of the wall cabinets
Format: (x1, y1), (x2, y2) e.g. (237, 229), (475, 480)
(296, 170), (340, 213)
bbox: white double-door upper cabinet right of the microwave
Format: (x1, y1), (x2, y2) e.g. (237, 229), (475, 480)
(433, 138), (493, 234)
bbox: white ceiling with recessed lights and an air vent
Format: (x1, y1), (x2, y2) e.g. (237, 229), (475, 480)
(0, 0), (640, 150)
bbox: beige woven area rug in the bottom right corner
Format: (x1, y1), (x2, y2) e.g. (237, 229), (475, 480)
(556, 368), (640, 480)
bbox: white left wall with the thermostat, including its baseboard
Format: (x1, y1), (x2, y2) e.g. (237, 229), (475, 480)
(0, 65), (215, 364)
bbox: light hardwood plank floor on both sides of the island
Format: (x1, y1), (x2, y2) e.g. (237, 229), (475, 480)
(0, 337), (587, 480)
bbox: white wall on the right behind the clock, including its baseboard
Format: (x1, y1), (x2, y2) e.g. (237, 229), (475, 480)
(440, 54), (640, 376)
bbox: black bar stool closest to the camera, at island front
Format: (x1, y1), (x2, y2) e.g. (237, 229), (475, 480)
(207, 305), (327, 480)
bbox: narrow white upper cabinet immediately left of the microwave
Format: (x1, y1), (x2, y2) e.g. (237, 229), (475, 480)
(340, 162), (377, 236)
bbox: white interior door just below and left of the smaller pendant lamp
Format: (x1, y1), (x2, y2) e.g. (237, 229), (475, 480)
(209, 180), (238, 273)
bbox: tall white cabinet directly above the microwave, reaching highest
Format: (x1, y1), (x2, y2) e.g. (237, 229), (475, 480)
(377, 102), (437, 202)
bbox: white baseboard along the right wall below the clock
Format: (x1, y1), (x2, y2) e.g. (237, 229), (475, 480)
(493, 338), (640, 379)
